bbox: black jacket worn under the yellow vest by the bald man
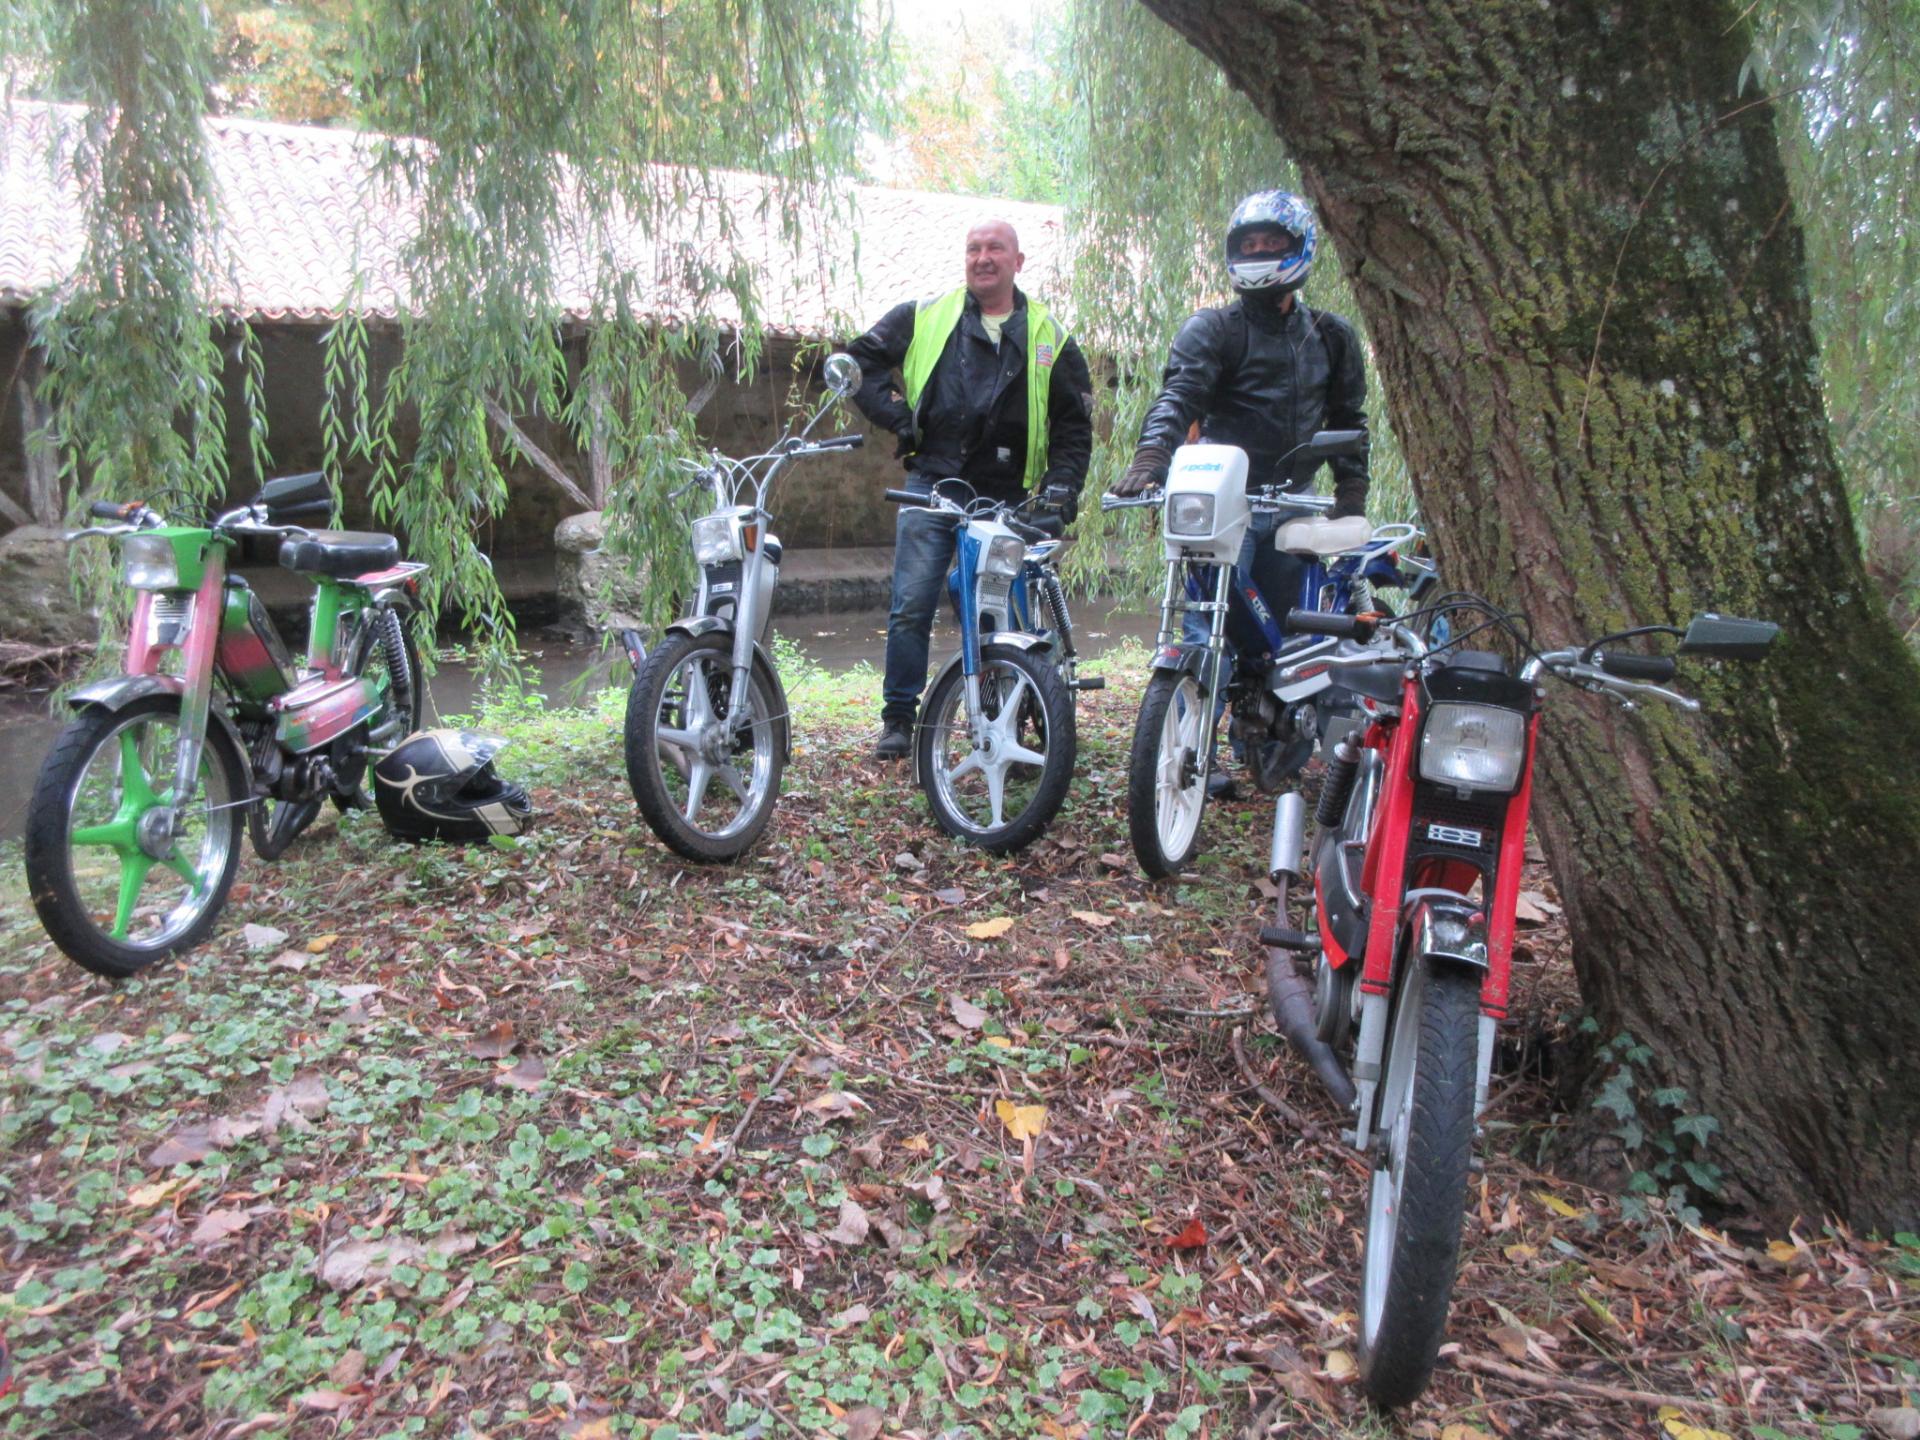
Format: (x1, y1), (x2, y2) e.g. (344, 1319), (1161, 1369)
(847, 290), (1092, 501)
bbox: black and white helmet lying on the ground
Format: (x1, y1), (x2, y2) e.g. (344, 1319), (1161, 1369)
(372, 730), (534, 841)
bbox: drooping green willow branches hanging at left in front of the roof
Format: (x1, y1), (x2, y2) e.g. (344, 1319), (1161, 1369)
(4, 0), (874, 637)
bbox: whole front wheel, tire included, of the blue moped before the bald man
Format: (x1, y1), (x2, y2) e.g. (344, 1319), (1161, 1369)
(914, 643), (1077, 854)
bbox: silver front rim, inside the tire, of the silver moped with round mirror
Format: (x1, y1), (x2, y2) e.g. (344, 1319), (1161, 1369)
(653, 651), (774, 841)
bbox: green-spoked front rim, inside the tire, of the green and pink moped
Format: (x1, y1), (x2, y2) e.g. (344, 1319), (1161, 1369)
(67, 712), (240, 950)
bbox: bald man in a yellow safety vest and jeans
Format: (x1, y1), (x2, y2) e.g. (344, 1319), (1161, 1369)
(849, 219), (1092, 760)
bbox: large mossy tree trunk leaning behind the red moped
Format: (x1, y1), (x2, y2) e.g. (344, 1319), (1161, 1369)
(1146, 0), (1920, 1231)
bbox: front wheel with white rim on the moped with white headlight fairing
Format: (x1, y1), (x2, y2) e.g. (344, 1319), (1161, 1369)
(1127, 670), (1212, 879)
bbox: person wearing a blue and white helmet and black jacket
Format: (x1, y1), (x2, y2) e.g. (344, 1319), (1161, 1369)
(1114, 190), (1367, 793)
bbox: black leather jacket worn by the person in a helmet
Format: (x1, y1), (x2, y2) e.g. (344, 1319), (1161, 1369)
(1140, 300), (1367, 515)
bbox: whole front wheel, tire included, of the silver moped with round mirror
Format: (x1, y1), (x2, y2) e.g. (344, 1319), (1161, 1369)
(626, 630), (787, 864)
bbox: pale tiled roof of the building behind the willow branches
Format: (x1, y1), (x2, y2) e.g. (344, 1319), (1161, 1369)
(0, 100), (1068, 336)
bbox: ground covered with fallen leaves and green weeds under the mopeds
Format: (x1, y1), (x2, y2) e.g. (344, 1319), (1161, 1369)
(0, 659), (1920, 1440)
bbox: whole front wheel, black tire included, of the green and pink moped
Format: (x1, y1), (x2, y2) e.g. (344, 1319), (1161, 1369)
(25, 695), (248, 977)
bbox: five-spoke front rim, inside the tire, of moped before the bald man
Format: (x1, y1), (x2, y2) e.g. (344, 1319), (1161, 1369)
(931, 655), (1050, 835)
